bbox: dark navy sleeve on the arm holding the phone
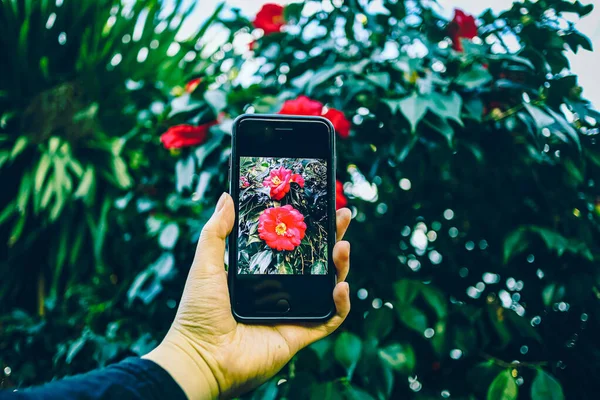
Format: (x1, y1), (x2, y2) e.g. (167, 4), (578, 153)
(0, 357), (186, 400)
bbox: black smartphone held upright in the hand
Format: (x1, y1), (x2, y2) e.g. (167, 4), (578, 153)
(228, 114), (336, 322)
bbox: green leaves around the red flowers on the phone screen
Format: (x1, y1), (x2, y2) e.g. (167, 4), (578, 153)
(238, 157), (327, 275)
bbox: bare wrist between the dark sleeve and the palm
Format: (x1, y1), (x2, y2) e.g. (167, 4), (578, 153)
(142, 332), (220, 400)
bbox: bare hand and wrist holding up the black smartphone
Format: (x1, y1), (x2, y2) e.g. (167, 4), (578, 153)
(144, 193), (351, 399)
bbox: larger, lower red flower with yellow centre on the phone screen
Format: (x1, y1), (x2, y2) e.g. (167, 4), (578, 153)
(258, 204), (306, 251)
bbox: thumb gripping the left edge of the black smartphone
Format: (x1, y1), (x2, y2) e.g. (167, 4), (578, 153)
(192, 193), (235, 272)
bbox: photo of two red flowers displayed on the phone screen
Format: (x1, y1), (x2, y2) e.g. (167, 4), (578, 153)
(238, 157), (328, 275)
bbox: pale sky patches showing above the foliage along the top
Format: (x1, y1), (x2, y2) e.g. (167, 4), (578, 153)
(190, 0), (600, 108)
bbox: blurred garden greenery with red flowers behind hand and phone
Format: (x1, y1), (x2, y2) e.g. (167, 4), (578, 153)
(0, 0), (600, 400)
